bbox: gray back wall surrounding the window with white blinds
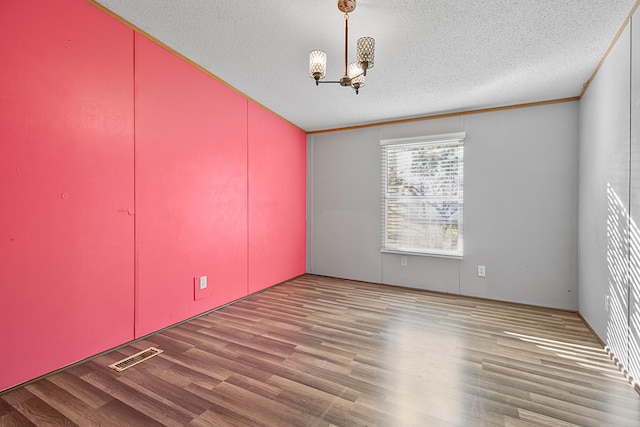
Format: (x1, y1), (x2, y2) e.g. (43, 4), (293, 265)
(307, 102), (578, 309)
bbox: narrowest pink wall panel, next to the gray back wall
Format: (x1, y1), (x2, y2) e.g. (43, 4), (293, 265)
(249, 102), (307, 293)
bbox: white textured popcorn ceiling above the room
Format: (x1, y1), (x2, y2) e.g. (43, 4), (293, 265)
(98, 0), (636, 131)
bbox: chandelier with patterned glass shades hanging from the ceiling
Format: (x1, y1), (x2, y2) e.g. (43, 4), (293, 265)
(309, 0), (375, 94)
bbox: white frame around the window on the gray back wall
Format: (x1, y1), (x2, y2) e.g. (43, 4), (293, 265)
(380, 132), (466, 259)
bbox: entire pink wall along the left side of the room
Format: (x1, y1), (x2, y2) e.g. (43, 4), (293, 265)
(0, 0), (306, 390)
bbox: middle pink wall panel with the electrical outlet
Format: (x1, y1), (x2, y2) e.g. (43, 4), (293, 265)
(135, 35), (247, 336)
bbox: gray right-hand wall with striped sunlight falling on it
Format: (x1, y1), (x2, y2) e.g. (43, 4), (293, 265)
(578, 13), (640, 378)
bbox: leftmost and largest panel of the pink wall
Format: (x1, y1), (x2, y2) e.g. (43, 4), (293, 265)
(0, 0), (134, 390)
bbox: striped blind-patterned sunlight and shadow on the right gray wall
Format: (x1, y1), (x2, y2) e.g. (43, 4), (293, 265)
(605, 183), (640, 381)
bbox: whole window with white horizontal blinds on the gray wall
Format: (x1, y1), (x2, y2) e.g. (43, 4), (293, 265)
(380, 132), (465, 257)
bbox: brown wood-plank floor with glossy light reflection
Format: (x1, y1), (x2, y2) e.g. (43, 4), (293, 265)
(0, 275), (640, 427)
